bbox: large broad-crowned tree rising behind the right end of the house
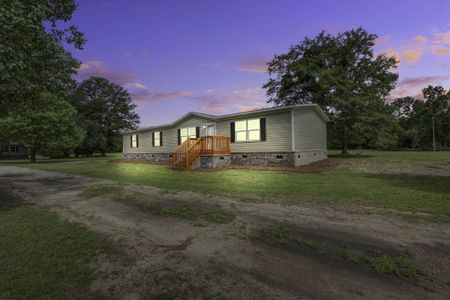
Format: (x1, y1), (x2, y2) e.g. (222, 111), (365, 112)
(264, 28), (398, 154)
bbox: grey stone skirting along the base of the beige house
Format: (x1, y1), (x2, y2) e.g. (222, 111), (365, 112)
(123, 150), (328, 169)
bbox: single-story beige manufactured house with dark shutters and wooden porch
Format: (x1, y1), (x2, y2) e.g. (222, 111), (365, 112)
(123, 104), (329, 169)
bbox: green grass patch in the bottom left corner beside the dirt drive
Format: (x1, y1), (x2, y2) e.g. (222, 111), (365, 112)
(0, 207), (111, 299)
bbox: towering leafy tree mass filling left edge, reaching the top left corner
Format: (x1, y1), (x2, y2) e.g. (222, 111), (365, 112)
(0, 0), (85, 161)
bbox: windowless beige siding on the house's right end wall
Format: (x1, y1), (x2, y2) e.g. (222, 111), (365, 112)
(293, 107), (327, 151)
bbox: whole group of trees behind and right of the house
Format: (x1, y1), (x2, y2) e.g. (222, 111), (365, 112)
(264, 28), (450, 154)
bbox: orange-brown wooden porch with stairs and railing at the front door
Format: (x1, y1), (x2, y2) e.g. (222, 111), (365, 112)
(172, 136), (230, 169)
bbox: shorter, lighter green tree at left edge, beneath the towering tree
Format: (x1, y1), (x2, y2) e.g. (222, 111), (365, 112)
(0, 93), (84, 162)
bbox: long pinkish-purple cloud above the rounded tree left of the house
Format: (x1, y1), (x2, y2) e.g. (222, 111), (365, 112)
(75, 60), (192, 102)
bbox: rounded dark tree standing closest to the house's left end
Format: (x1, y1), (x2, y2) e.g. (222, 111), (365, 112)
(72, 77), (139, 155)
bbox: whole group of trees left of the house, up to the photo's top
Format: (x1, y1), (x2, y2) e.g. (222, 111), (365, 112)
(0, 0), (139, 162)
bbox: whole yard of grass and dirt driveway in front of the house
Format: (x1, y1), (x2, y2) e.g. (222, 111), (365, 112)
(0, 150), (450, 299)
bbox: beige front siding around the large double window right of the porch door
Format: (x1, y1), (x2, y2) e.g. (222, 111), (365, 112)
(216, 111), (292, 152)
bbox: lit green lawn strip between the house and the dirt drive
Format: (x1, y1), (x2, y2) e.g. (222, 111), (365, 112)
(3, 151), (450, 221)
